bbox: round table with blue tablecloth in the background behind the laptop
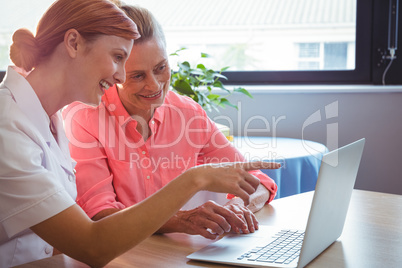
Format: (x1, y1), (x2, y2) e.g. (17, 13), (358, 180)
(233, 137), (328, 198)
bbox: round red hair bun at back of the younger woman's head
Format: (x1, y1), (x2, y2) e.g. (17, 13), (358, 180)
(10, 29), (39, 72)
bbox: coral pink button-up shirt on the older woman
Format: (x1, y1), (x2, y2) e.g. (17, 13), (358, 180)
(63, 86), (277, 218)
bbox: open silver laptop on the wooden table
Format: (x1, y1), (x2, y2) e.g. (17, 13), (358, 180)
(187, 139), (365, 267)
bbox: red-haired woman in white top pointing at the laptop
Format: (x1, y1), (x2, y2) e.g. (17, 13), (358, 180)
(0, 0), (278, 267)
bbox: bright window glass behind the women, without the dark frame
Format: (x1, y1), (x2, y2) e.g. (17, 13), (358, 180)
(0, 0), (356, 71)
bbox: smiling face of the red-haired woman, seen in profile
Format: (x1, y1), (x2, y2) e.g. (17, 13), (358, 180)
(74, 35), (133, 105)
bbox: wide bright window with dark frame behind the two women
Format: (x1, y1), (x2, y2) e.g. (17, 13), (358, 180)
(0, 0), (402, 84)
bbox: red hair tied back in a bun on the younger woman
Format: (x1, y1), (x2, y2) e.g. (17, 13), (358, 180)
(10, 0), (139, 71)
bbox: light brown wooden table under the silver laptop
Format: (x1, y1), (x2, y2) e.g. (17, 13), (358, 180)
(15, 190), (402, 268)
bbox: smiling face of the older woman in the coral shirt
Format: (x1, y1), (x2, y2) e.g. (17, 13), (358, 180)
(119, 38), (170, 120)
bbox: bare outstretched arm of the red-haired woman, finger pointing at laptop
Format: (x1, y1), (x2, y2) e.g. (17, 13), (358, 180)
(31, 162), (274, 266)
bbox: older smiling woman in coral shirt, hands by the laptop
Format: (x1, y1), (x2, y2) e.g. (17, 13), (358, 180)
(63, 5), (277, 239)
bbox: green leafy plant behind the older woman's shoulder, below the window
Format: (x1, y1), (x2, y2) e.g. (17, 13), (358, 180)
(170, 48), (252, 139)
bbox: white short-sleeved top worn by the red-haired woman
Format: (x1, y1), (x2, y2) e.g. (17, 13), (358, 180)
(0, 67), (77, 267)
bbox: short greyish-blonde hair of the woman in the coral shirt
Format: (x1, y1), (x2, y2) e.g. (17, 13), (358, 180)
(120, 5), (166, 46)
